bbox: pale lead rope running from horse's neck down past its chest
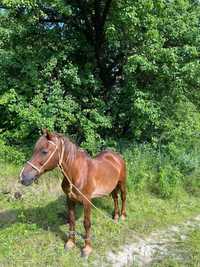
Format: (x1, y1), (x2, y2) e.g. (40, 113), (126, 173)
(58, 139), (113, 223)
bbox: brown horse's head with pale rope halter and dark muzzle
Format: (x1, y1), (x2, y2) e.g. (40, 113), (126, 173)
(20, 130), (59, 185)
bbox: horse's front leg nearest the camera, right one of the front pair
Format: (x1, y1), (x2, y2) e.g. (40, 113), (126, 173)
(82, 199), (92, 257)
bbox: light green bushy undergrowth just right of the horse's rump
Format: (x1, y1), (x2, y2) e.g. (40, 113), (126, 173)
(123, 144), (200, 198)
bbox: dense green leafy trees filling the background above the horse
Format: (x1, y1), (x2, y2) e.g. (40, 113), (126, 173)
(0, 0), (200, 197)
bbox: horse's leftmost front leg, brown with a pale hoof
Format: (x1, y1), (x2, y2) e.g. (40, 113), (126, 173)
(65, 198), (75, 249)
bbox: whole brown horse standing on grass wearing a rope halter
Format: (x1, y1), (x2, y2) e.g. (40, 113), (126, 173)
(20, 130), (126, 256)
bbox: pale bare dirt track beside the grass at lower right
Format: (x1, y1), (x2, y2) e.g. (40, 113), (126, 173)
(105, 215), (200, 267)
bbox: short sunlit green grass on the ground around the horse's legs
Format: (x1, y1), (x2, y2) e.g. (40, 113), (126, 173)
(0, 164), (200, 267)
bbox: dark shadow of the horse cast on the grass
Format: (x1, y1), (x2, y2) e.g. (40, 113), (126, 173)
(0, 195), (112, 241)
